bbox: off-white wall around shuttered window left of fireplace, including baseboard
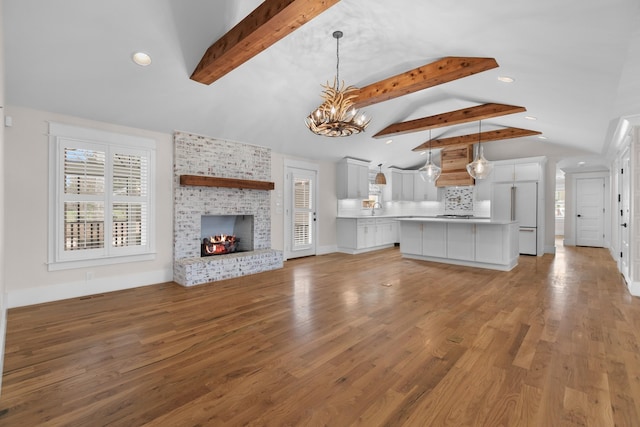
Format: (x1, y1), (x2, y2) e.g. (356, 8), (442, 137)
(2, 106), (173, 307)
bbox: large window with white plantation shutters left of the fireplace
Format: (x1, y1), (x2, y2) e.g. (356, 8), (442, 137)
(49, 123), (155, 270)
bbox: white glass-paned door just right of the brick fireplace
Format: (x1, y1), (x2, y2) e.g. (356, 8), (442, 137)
(285, 167), (317, 259)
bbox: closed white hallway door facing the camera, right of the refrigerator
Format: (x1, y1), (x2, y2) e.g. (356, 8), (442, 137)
(576, 178), (604, 247)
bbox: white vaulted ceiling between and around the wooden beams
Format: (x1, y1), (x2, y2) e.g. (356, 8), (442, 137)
(3, 0), (640, 171)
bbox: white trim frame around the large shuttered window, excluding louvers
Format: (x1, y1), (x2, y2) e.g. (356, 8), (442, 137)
(47, 122), (156, 271)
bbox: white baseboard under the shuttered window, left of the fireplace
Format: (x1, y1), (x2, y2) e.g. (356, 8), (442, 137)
(7, 269), (173, 308)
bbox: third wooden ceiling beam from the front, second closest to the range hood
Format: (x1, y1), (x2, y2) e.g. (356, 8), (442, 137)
(373, 103), (527, 138)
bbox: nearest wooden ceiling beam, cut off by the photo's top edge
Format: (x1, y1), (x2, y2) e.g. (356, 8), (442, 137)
(191, 0), (340, 84)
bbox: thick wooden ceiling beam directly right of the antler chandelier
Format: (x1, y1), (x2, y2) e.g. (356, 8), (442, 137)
(355, 56), (498, 108)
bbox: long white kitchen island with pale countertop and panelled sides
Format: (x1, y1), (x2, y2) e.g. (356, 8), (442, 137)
(398, 217), (519, 271)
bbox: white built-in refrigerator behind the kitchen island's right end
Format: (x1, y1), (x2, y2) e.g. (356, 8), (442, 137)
(491, 182), (538, 255)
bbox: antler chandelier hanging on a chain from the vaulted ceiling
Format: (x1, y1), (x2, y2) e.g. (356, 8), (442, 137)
(305, 31), (371, 137)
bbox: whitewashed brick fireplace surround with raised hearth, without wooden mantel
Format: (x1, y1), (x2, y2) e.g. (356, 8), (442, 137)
(173, 132), (283, 286)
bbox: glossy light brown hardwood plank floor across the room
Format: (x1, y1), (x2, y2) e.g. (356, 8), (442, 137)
(0, 242), (640, 427)
